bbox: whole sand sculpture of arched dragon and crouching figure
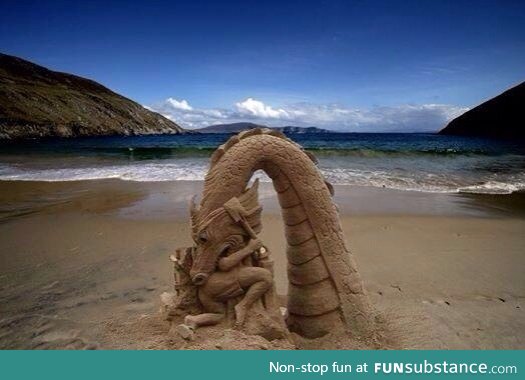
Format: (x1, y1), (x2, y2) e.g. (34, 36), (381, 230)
(170, 129), (371, 339)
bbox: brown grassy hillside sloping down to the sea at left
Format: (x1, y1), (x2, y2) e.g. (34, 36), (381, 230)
(0, 54), (184, 139)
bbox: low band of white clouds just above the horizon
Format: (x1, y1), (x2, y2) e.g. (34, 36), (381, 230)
(149, 98), (468, 132)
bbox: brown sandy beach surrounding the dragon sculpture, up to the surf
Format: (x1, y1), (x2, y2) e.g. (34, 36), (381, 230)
(0, 180), (525, 349)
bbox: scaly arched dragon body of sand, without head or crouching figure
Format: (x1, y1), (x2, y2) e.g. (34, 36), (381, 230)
(188, 129), (371, 337)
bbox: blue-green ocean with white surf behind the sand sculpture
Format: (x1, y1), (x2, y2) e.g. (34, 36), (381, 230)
(0, 133), (525, 194)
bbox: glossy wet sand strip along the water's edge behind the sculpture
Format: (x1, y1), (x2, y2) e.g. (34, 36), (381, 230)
(0, 179), (525, 220)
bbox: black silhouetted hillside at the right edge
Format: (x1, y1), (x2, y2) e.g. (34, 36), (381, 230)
(439, 82), (525, 139)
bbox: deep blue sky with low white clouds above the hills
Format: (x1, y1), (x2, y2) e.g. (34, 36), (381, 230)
(0, 0), (525, 131)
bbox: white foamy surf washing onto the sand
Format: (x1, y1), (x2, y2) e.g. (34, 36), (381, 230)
(0, 162), (525, 194)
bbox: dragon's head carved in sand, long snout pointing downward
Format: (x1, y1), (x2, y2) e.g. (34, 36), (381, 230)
(190, 181), (262, 285)
